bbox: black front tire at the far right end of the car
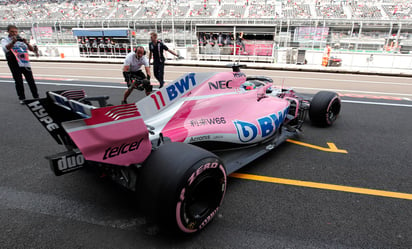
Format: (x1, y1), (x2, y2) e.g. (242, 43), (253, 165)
(309, 91), (341, 126)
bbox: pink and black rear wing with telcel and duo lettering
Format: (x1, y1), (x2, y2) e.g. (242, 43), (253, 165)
(25, 90), (152, 175)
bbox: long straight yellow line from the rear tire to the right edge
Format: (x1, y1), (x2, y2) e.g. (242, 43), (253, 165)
(230, 173), (412, 200)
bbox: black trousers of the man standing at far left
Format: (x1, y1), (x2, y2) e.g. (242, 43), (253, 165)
(8, 62), (39, 100)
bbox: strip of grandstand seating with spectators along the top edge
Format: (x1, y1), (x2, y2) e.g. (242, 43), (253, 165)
(0, 0), (412, 22)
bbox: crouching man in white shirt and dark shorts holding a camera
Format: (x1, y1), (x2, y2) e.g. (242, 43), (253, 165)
(122, 46), (152, 104)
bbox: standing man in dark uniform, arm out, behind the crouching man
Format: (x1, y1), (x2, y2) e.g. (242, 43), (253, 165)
(149, 32), (178, 88)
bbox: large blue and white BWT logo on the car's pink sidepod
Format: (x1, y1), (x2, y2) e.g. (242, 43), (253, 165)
(233, 108), (288, 143)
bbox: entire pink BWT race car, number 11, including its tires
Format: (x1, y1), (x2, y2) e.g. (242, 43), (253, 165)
(26, 64), (341, 234)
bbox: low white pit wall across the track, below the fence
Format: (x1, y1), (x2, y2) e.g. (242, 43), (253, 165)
(0, 44), (412, 70)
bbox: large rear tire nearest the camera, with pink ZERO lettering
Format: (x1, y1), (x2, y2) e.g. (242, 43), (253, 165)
(137, 143), (227, 234)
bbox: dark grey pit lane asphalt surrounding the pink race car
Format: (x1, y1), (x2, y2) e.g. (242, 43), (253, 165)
(0, 63), (412, 248)
